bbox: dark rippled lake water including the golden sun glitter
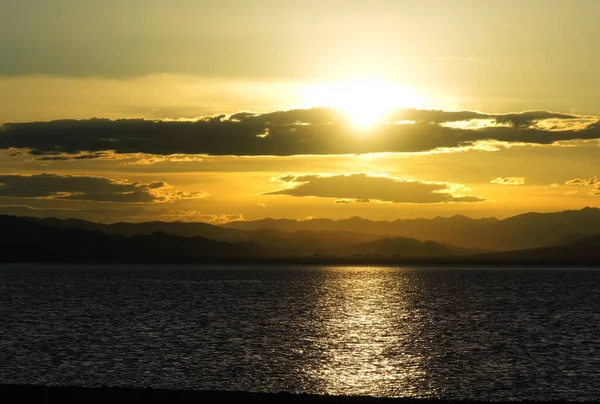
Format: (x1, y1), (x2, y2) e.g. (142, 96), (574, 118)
(0, 265), (600, 400)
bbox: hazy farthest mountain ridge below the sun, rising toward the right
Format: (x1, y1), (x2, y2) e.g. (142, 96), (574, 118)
(222, 207), (600, 251)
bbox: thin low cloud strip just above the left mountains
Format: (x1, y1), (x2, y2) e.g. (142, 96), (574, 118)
(0, 205), (245, 224)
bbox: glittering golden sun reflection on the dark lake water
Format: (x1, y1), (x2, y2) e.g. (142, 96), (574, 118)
(304, 267), (434, 397)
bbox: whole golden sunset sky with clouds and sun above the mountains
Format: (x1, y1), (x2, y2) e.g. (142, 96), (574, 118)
(0, 0), (600, 223)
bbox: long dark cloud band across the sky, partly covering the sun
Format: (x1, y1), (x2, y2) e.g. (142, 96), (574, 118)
(0, 108), (600, 157)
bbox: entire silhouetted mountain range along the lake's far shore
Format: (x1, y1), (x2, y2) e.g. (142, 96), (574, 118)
(0, 208), (600, 264)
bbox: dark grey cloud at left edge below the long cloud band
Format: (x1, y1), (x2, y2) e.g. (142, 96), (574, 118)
(0, 174), (206, 203)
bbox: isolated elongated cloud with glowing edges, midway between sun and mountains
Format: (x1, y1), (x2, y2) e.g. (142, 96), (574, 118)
(263, 173), (484, 203)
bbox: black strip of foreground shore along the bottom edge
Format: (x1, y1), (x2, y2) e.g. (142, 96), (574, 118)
(0, 385), (592, 404)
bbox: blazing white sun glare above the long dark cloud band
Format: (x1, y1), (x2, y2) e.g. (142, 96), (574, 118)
(304, 77), (422, 128)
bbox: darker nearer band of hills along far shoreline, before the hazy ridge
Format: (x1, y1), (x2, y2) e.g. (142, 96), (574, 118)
(0, 215), (600, 265)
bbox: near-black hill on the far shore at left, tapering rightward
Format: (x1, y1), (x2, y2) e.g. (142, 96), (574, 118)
(0, 215), (266, 263)
